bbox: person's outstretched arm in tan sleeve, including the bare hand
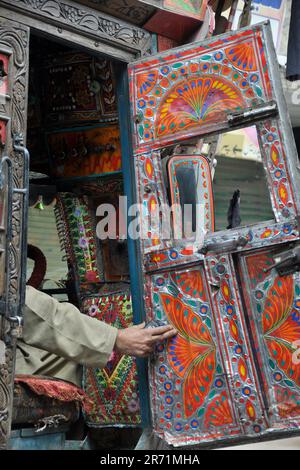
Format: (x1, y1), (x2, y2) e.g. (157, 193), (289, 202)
(23, 287), (176, 368)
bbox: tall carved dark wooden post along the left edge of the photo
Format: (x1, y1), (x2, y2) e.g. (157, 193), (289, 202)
(0, 9), (29, 449)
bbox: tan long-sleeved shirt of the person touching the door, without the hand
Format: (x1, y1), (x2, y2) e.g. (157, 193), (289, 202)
(16, 286), (118, 386)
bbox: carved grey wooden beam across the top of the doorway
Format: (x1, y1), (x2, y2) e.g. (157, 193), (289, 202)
(0, 0), (152, 62)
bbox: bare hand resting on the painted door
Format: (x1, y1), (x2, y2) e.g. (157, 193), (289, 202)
(115, 323), (177, 357)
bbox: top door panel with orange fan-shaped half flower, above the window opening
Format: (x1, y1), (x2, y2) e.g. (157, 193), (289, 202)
(129, 25), (271, 153)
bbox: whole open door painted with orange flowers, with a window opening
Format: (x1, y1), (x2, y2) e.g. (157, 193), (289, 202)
(129, 23), (300, 446)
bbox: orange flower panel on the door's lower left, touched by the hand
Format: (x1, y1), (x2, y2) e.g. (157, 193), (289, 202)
(150, 268), (241, 446)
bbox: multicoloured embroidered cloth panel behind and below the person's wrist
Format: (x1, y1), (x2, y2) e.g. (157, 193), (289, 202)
(82, 293), (141, 427)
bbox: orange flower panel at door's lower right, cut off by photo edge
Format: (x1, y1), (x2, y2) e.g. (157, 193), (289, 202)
(242, 250), (300, 423)
